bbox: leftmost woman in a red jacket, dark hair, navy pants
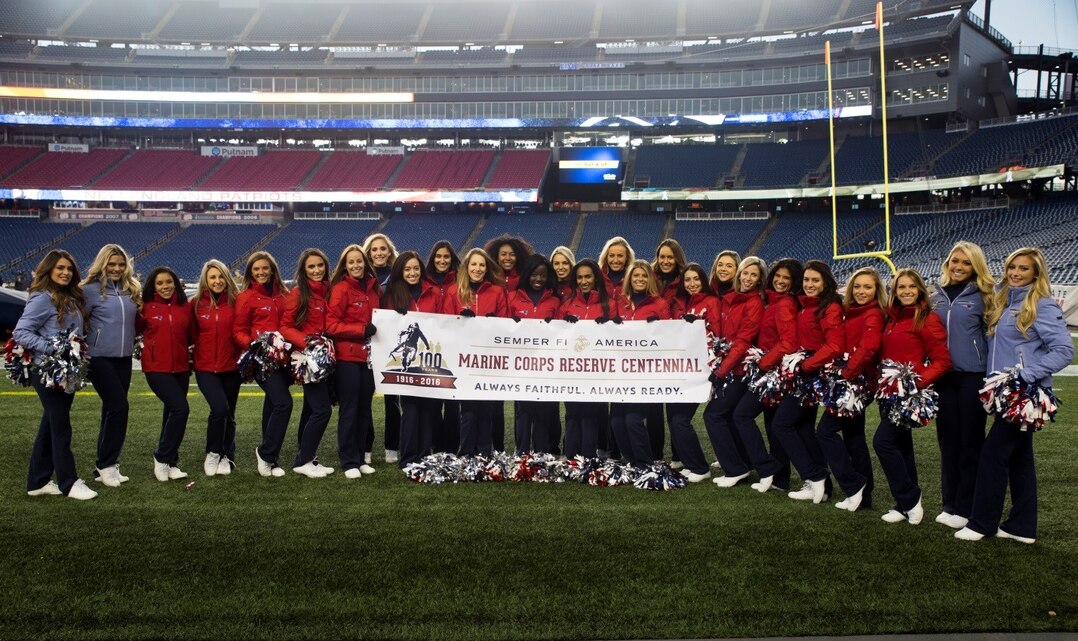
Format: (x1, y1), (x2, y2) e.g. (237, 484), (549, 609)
(138, 267), (194, 480)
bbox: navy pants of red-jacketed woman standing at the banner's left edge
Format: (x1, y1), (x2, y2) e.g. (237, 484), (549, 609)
(333, 361), (374, 470)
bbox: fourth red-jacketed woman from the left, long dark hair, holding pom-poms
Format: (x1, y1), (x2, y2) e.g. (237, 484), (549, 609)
(280, 248), (333, 478)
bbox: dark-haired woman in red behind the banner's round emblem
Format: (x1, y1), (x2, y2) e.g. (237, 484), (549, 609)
(558, 259), (620, 459)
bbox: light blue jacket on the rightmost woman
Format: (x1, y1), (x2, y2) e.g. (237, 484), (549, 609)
(989, 285), (1075, 387)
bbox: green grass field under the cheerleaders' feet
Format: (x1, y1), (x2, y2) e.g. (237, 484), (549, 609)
(0, 373), (1078, 640)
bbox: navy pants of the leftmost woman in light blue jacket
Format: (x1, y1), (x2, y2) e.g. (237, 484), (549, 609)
(26, 376), (79, 494)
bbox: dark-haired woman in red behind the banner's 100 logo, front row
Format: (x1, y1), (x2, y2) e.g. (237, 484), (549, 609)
(382, 251), (439, 469)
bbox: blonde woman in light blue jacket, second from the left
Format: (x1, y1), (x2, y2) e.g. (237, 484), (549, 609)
(82, 243), (142, 487)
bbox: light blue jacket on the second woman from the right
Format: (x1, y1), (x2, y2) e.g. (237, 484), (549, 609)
(928, 282), (989, 374)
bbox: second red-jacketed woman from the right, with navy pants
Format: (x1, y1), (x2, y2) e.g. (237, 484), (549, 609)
(816, 267), (886, 512)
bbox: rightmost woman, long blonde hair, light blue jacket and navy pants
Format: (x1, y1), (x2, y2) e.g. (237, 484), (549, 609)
(954, 247), (1075, 543)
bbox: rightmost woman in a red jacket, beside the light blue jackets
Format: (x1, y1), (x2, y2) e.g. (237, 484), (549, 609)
(872, 269), (951, 526)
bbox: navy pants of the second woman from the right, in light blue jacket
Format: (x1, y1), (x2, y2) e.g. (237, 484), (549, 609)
(936, 372), (989, 518)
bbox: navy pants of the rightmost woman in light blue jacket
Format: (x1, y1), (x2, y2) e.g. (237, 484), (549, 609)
(968, 416), (1037, 539)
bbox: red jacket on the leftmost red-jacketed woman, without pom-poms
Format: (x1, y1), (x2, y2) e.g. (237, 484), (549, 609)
(136, 294), (194, 374)
